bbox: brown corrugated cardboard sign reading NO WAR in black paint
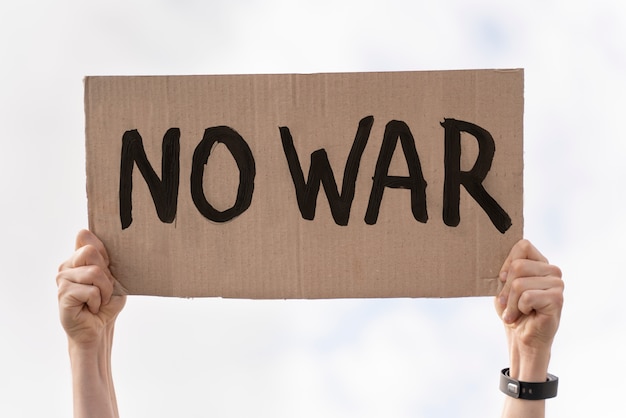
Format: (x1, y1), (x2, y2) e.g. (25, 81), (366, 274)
(85, 70), (523, 298)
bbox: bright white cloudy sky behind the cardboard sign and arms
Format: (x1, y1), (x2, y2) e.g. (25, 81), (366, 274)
(0, 0), (626, 418)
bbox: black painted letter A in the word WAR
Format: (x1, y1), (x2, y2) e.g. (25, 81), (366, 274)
(365, 120), (428, 225)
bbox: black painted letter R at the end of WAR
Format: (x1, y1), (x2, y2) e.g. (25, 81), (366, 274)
(441, 119), (511, 234)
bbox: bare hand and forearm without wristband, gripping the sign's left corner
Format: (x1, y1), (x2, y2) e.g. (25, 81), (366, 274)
(57, 230), (126, 418)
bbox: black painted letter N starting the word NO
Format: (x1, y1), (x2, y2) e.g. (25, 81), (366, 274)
(119, 128), (180, 229)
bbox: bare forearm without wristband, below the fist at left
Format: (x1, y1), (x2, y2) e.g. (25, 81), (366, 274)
(69, 327), (119, 418)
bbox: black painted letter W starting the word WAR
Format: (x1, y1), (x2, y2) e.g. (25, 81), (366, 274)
(279, 116), (374, 226)
